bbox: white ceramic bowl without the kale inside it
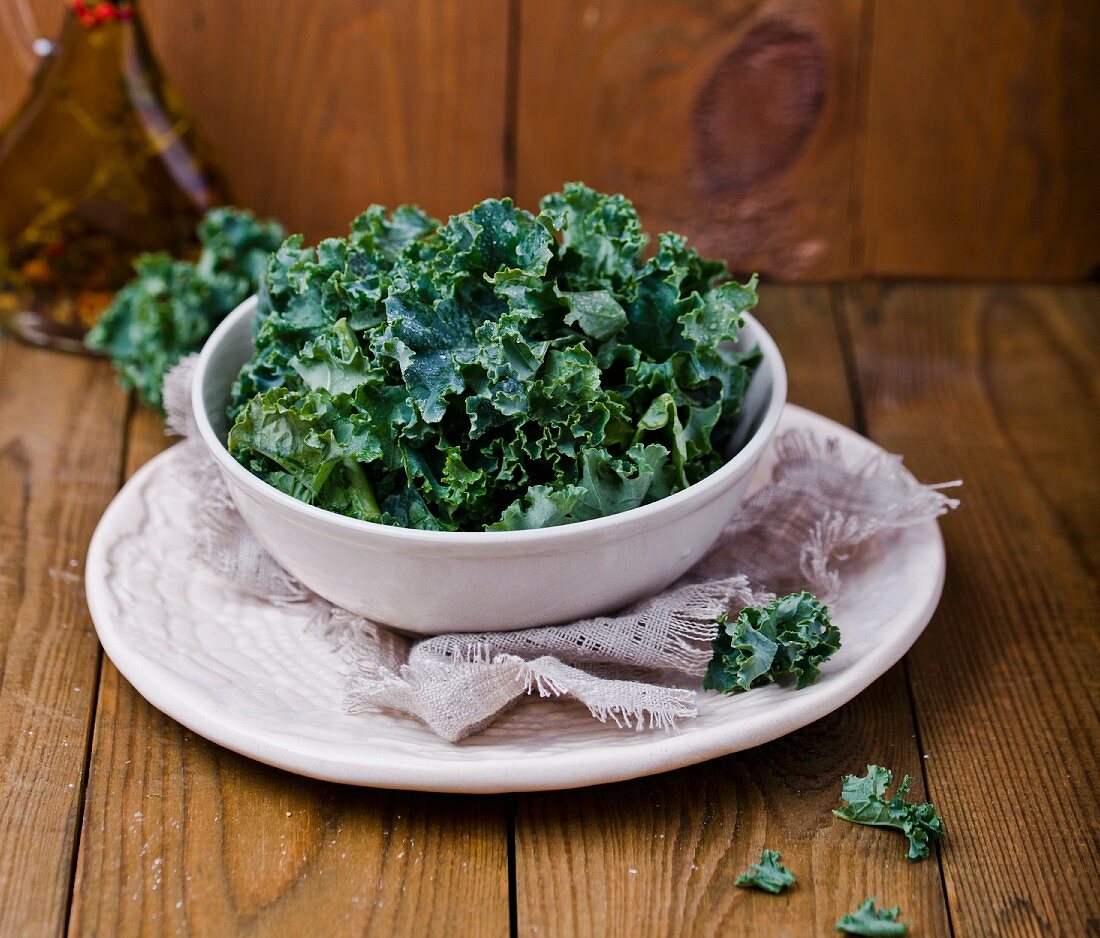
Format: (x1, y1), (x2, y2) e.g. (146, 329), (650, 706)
(191, 297), (787, 634)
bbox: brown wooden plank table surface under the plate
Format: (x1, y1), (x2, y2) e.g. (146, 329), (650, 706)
(0, 284), (1100, 936)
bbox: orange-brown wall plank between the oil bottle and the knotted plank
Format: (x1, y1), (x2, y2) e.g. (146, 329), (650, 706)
(146, 0), (508, 239)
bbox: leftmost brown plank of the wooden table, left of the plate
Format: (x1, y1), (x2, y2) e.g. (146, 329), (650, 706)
(0, 340), (127, 936)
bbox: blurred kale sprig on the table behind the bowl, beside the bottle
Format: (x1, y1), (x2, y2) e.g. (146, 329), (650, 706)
(85, 208), (284, 410)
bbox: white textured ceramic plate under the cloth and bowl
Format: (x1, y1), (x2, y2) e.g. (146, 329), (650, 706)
(87, 406), (944, 792)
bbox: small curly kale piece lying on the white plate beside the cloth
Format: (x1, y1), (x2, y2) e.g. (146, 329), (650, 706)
(703, 593), (840, 694)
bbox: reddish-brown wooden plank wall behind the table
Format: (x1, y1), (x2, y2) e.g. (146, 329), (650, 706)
(0, 0), (1100, 279)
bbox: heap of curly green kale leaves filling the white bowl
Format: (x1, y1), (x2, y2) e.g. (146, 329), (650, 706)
(229, 184), (759, 531)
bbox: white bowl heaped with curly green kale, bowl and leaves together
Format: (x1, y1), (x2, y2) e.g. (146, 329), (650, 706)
(193, 184), (787, 633)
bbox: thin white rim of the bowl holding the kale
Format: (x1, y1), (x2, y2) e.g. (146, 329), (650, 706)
(191, 295), (787, 547)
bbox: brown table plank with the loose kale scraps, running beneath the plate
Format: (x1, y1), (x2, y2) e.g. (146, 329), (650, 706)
(516, 286), (949, 936)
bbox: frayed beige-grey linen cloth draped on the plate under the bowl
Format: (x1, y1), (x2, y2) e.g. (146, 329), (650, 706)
(164, 356), (958, 741)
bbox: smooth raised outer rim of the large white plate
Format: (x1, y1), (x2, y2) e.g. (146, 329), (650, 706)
(85, 404), (946, 794)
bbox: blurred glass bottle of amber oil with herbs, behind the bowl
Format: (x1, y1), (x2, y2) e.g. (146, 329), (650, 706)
(0, 0), (224, 350)
